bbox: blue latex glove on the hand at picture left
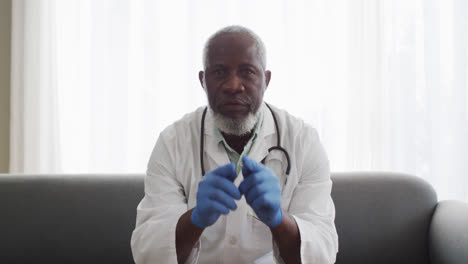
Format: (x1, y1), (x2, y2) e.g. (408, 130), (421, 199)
(190, 163), (241, 228)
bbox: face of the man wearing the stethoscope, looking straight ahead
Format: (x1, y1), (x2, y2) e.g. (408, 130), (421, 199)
(199, 33), (271, 120)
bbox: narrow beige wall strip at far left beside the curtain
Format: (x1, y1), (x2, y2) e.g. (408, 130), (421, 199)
(0, 0), (11, 173)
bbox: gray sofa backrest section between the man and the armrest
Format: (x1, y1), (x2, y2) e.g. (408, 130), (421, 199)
(332, 172), (437, 264)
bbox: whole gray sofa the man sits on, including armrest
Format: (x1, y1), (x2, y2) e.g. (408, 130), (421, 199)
(0, 173), (468, 264)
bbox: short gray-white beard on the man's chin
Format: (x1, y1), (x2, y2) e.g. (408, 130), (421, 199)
(209, 107), (261, 136)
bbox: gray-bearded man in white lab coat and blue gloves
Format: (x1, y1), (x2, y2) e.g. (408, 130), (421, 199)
(131, 26), (338, 263)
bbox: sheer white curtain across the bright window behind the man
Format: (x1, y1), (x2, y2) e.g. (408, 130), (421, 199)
(10, 0), (468, 201)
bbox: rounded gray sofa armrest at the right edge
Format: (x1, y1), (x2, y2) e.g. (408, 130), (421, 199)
(429, 201), (468, 264)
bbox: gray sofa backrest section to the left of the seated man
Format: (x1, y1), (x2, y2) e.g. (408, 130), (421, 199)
(0, 175), (144, 264)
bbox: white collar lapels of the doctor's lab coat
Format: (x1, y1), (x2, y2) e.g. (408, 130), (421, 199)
(204, 102), (275, 168)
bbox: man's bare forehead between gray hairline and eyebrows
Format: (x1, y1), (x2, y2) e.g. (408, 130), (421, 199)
(207, 33), (261, 68)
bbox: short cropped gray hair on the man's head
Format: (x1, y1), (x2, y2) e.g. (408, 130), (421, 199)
(203, 26), (266, 70)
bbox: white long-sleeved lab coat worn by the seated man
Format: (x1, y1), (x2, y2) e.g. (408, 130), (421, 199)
(131, 104), (338, 264)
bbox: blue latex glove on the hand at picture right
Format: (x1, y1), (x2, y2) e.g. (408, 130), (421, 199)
(239, 156), (283, 227)
